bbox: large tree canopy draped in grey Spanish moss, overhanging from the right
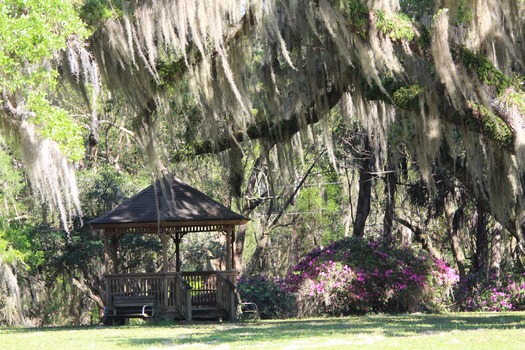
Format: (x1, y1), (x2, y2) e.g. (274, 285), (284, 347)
(71, 0), (525, 241)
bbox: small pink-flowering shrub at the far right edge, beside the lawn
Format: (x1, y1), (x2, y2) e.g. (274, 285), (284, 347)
(459, 274), (525, 311)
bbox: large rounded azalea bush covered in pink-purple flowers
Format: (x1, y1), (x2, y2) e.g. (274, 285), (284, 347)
(286, 237), (459, 315)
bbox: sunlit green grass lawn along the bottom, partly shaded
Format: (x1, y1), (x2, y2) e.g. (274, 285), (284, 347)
(0, 312), (525, 350)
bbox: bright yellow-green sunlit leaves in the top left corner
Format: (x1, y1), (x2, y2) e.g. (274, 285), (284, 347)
(0, 0), (87, 160)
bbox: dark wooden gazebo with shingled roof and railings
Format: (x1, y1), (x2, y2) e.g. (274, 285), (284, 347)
(90, 176), (248, 323)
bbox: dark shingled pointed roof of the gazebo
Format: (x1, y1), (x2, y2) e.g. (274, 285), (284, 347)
(90, 176), (248, 228)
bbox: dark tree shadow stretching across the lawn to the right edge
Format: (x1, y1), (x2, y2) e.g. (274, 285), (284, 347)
(121, 313), (525, 345)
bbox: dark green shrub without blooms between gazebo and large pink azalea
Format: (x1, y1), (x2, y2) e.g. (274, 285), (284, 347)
(237, 275), (297, 318)
